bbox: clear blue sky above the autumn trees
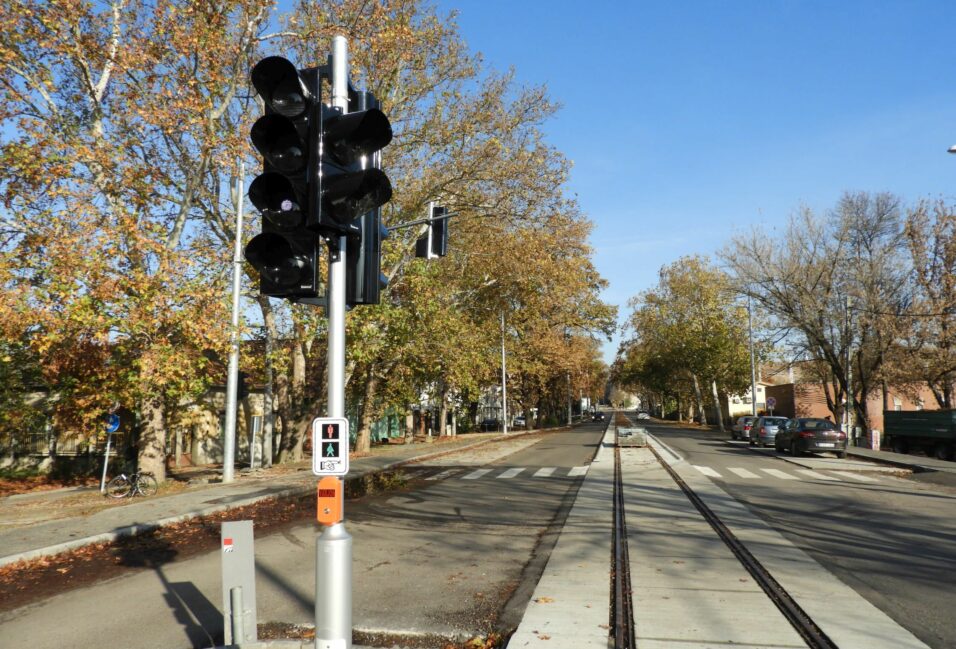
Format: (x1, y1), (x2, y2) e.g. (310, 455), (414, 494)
(438, 0), (956, 362)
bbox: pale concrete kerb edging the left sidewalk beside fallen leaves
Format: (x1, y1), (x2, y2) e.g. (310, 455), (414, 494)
(0, 428), (561, 567)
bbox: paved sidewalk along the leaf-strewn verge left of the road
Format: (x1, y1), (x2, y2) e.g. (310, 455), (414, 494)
(0, 431), (520, 566)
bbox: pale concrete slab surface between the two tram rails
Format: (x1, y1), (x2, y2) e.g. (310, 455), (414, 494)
(621, 449), (806, 647)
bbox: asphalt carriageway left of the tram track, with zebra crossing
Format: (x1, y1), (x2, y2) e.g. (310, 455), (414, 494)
(0, 423), (606, 649)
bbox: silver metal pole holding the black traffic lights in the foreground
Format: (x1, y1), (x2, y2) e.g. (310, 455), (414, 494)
(315, 36), (352, 649)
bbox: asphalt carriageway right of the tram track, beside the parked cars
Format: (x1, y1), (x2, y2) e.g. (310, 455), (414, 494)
(642, 422), (956, 648)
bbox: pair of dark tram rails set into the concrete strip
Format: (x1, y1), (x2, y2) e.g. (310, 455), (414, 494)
(611, 416), (837, 649)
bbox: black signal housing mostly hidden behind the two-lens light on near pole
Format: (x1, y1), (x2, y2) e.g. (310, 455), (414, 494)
(345, 92), (391, 306)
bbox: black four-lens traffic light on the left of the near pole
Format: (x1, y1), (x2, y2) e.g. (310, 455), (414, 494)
(245, 56), (322, 302)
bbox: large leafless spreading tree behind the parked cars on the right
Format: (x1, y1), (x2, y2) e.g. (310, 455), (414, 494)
(721, 192), (908, 426)
